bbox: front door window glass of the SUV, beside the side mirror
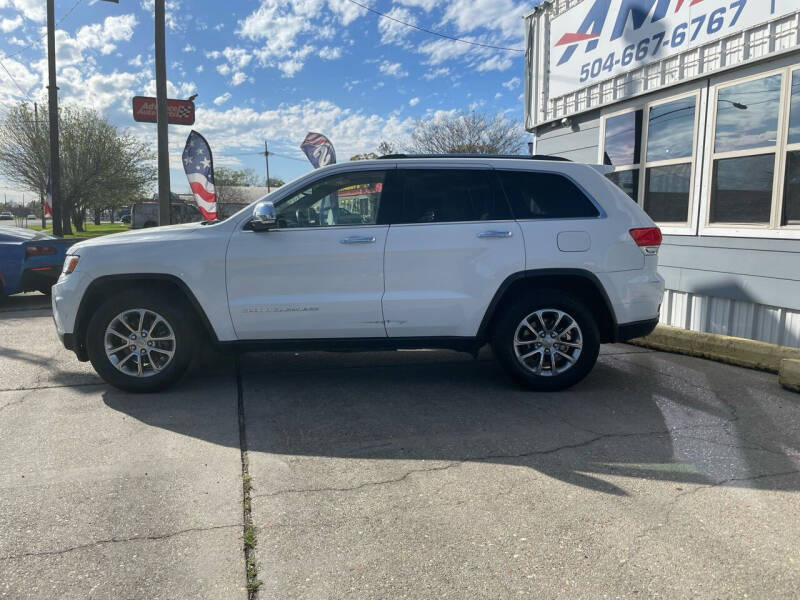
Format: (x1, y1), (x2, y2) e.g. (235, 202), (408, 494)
(276, 171), (386, 229)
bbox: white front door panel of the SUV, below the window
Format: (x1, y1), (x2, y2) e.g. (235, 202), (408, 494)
(227, 225), (389, 340)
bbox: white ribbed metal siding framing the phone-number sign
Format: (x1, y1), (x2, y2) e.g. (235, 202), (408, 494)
(525, 0), (800, 129)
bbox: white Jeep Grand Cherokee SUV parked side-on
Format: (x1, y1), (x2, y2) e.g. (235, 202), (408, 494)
(53, 155), (664, 391)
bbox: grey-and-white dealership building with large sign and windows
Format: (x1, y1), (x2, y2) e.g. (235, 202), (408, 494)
(525, 0), (800, 347)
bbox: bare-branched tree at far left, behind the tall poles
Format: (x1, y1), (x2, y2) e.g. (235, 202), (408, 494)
(0, 103), (157, 234)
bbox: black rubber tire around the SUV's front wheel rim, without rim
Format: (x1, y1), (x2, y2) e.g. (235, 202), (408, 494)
(86, 290), (199, 393)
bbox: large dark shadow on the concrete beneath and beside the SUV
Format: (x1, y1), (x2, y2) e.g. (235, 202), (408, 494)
(104, 349), (800, 496)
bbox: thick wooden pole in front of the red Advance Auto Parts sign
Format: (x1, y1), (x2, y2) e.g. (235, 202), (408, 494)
(155, 0), (170, 225)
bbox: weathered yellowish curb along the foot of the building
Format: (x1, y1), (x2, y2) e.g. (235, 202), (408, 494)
(629, 325), (800, 376)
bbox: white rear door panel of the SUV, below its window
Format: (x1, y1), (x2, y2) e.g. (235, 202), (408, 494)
(383, 221), (525, 337)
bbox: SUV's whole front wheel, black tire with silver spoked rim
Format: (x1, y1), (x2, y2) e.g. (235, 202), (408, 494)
(86, 291), (197, 392)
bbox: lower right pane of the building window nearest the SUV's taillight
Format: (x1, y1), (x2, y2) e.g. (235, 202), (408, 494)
(644, 163), (692, 223)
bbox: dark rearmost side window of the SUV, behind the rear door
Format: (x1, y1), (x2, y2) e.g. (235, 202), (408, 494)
(497, 171), (600, 219)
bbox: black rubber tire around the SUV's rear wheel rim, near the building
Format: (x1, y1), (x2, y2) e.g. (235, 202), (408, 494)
(491, 290), (600, 392)
